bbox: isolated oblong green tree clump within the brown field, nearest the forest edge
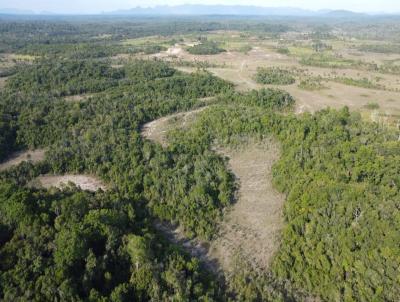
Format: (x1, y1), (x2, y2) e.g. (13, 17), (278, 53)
(254, 67), (296, 85)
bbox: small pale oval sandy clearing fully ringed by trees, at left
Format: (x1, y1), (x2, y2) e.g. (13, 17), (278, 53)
(31, 174), (107, 192)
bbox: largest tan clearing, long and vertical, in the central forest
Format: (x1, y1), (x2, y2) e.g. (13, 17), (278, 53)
(209, 139), (285, 271)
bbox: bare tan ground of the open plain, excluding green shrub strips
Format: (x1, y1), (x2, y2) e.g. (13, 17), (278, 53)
(145, 36), (400, 122)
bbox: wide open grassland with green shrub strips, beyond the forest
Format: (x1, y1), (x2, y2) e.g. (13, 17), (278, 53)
(131, 31), (400, 125)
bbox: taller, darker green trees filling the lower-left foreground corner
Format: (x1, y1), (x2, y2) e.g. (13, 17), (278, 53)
(0, 182), (219, 301)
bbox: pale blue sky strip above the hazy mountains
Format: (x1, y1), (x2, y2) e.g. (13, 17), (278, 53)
(0, 0), (400, 14)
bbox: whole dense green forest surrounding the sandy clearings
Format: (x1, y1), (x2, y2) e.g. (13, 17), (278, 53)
(0, 17), (400, 301)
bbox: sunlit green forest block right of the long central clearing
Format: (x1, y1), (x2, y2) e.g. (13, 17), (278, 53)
(268, 110), (400, 301)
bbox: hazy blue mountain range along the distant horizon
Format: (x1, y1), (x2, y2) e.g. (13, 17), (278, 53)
(0, 5), (394, 18)
